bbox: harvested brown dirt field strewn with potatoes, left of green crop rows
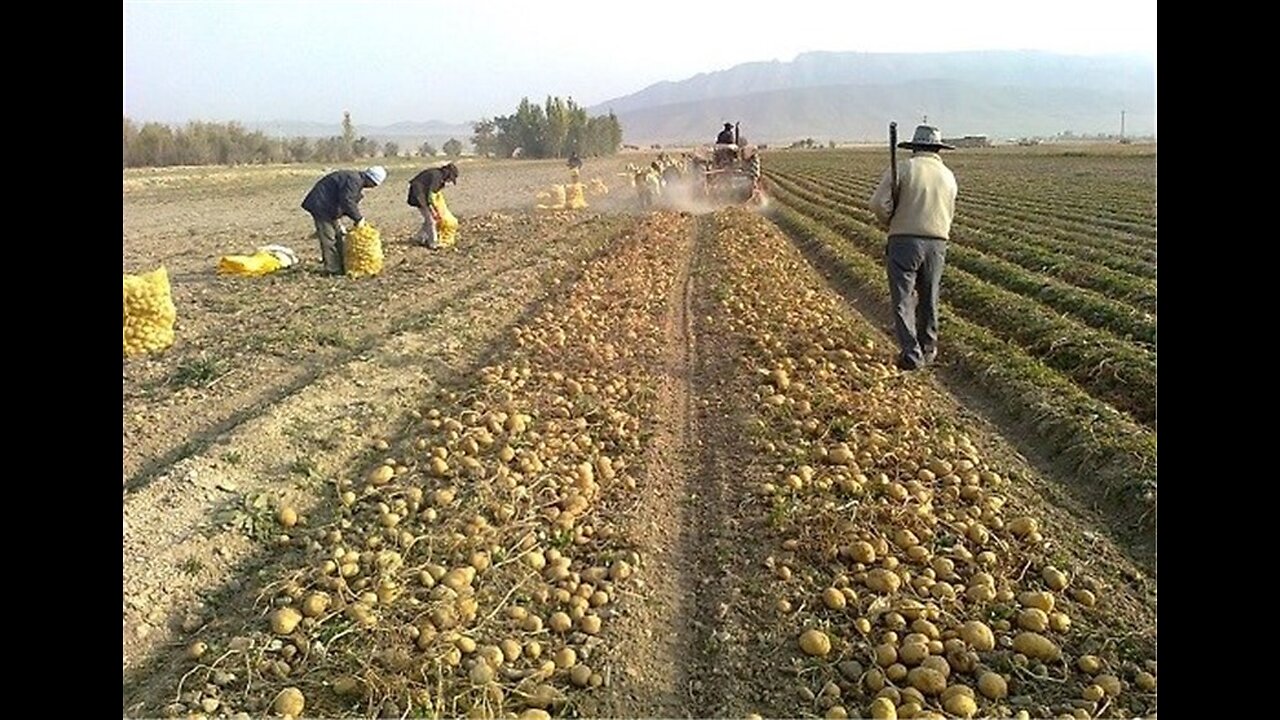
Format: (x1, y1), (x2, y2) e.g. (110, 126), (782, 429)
(123, 156), (1156, 717)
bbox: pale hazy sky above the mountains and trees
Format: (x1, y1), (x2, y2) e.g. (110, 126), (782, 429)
(124, 0), (1156, 126)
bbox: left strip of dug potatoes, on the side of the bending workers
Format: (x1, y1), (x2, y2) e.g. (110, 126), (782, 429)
(164, 212), (687, 717)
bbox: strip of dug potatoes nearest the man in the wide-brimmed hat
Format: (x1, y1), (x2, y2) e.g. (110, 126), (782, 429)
(716, 210), (1156, 719)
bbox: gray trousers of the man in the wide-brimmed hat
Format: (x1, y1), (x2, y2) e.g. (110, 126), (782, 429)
(884, 234), (947, 366)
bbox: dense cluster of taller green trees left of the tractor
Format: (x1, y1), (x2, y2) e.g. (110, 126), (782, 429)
(471, 96), (622, 158)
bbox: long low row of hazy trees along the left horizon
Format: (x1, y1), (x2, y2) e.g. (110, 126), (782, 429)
(124, 113), (462, 168)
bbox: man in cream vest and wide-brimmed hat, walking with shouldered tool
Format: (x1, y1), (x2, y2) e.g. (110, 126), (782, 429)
(870, 126), (957, 370)
